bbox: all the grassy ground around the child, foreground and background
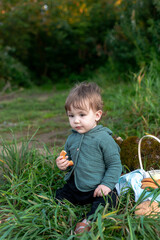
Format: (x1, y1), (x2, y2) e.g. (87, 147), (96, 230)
(0, 68), (160, 240)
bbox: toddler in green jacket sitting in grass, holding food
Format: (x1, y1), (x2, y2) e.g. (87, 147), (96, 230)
(56, 82), (122, 234)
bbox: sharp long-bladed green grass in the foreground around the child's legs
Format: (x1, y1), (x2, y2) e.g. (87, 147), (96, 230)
(0, 134), (160, 240)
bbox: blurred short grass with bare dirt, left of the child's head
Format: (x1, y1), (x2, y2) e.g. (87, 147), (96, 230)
(0, 85), (68, 145)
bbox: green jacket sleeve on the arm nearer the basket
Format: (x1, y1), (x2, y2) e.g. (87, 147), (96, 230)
(101, 137), (122, 190)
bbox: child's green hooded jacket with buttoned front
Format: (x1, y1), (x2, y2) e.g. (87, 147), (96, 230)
(65, 125), (122, 192)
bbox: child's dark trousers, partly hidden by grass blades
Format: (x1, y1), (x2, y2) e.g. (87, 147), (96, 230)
(56, 175), (118, 218)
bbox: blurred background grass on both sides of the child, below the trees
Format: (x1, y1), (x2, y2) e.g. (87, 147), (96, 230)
(0, 68), (160, 146)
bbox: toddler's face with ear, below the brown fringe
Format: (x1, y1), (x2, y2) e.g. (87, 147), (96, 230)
(67, 103), (102, 133)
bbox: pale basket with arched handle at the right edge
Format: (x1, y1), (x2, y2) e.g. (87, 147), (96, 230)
(138, 135), (160, 180)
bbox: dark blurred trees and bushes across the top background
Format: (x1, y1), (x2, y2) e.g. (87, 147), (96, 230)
(0, 0), (160, 87)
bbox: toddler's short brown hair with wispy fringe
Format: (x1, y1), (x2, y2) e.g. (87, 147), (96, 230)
(65, 82), (103, 112)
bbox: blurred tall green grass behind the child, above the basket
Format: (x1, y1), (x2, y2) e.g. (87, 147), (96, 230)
(95, 62), (160, 138)
